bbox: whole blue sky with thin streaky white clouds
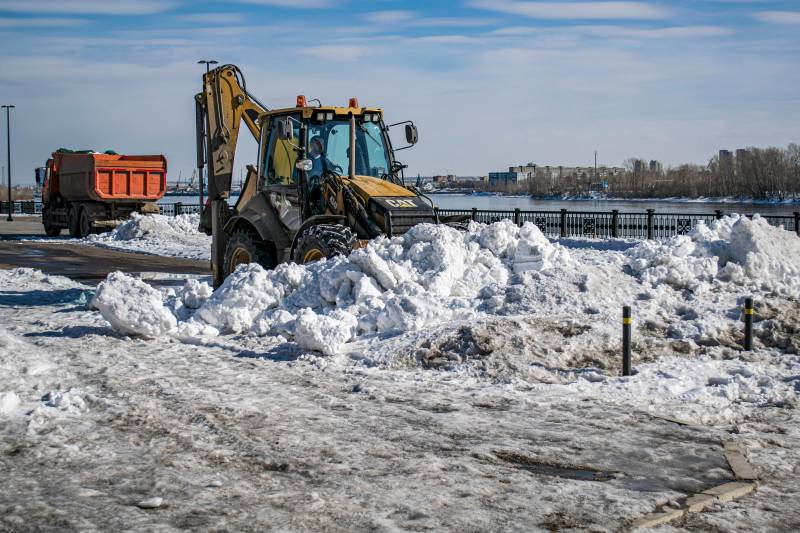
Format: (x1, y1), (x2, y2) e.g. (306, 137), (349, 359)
(0, 0), (800, 182)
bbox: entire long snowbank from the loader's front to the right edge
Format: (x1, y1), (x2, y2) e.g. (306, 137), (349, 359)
(90, 217), (800, 362)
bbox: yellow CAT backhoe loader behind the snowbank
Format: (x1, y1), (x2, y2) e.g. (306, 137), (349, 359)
(195, 65), (439, 286)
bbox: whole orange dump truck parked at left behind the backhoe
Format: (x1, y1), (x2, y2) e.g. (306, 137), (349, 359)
(36, 150), (167, 237)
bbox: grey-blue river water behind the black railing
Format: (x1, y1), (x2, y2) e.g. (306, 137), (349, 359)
(159, 194), (800, 215)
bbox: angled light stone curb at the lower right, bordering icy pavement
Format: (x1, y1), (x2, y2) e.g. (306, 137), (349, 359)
(629, 440), (758, 530)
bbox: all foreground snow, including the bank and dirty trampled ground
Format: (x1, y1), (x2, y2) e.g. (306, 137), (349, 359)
(0, 217), (800, 531)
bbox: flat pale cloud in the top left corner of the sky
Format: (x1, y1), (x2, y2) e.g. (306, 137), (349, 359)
(0, 0), (175, 15)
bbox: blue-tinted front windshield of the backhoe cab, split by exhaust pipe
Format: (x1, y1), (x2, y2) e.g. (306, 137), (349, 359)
(307, 120), (389, 179)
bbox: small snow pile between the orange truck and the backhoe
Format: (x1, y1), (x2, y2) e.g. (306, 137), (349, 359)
(80, 213), (211, 259)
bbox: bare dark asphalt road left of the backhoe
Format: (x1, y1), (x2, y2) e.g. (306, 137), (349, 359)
(0, 217), (210, 283)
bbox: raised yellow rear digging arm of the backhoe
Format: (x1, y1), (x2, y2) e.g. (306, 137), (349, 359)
(195, 65), (267, 234)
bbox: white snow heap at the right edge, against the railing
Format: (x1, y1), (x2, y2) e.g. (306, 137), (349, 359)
(627, 215), (800, 298)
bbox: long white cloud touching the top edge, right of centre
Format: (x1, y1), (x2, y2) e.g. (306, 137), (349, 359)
(469, 0), (672, 20)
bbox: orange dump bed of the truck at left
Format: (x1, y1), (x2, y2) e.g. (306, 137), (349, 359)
(53, 152), (167, 206)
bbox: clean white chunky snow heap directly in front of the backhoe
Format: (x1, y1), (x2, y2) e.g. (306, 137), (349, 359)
(94, 221), (571, 354)
